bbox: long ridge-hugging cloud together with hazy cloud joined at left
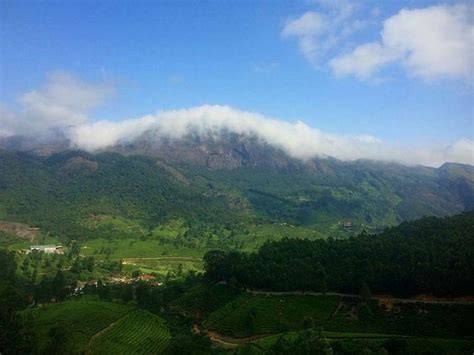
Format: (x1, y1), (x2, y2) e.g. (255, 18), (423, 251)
(0, 73), (474, 166)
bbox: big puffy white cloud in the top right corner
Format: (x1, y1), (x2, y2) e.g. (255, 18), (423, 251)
(329, 5), (474, 80)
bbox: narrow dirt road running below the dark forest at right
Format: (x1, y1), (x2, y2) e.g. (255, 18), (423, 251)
(246, 289), (474, 304)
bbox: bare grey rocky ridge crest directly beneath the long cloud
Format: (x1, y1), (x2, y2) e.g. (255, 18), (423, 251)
(0, 131), (474, 170)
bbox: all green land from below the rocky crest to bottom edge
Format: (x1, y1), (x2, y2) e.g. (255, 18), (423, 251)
(0, 146), (474, 354)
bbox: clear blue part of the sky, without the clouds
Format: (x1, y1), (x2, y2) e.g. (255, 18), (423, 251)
(0, 1), (474, 150)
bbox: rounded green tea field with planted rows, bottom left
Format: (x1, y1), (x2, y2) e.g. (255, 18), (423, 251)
(22, 297), (170, 354)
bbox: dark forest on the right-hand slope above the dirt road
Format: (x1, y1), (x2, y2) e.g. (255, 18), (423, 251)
(204, 212), (474, 295)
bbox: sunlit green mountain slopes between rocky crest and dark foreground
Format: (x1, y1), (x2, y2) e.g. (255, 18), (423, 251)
(0, 150), (474, 249)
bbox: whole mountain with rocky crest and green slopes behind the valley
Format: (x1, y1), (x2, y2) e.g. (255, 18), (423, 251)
(0, 134), (474, 242)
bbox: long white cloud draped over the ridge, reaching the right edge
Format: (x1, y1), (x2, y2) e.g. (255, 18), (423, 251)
(70, 105), (474, 166)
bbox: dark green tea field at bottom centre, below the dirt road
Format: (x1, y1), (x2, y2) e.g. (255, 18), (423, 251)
(204, 294), (339, 337)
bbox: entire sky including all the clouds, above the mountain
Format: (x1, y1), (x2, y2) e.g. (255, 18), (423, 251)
(0, 0), (474, 165)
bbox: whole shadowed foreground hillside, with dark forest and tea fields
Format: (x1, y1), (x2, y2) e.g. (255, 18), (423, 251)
(0, 212), (474, 354)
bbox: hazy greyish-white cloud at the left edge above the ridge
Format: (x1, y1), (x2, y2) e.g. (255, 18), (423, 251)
(0, 72), (114, 134)
